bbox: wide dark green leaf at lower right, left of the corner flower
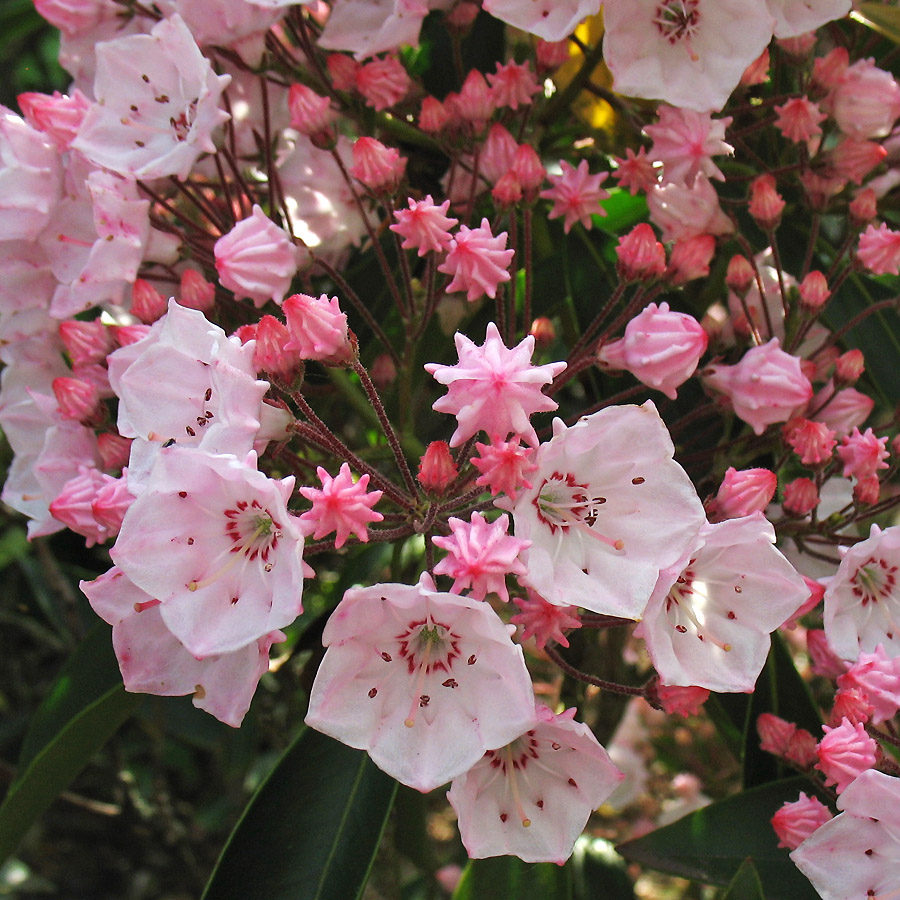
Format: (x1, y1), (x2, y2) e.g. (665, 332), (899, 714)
(617, 777), (818, 900)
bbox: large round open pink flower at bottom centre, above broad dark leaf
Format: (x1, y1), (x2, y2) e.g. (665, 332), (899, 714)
(306, 575), (534, 791)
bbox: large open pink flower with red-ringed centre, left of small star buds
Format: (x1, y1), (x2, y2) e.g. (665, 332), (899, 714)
(110, 446), (303, 657)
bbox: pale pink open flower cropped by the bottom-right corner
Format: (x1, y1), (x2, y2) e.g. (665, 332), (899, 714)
(791, 769), (900, 900)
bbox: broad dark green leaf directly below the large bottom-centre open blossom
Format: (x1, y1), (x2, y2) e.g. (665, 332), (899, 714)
(203, 729), (397, 900)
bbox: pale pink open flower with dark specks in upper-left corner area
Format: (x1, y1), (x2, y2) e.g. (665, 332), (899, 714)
(72, 15), (231, 179)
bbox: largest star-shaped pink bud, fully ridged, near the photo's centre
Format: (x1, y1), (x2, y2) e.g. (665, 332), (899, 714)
(425, 322), (566, 447)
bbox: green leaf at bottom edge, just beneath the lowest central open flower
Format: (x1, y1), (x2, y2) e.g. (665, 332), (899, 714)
(453, 856), (572, 900)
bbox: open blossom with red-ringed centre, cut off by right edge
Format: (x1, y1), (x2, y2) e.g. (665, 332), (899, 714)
(824, 525), (900, 660)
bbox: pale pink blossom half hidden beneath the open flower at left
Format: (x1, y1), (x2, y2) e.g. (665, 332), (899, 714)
(80, 566), (284, 728)
